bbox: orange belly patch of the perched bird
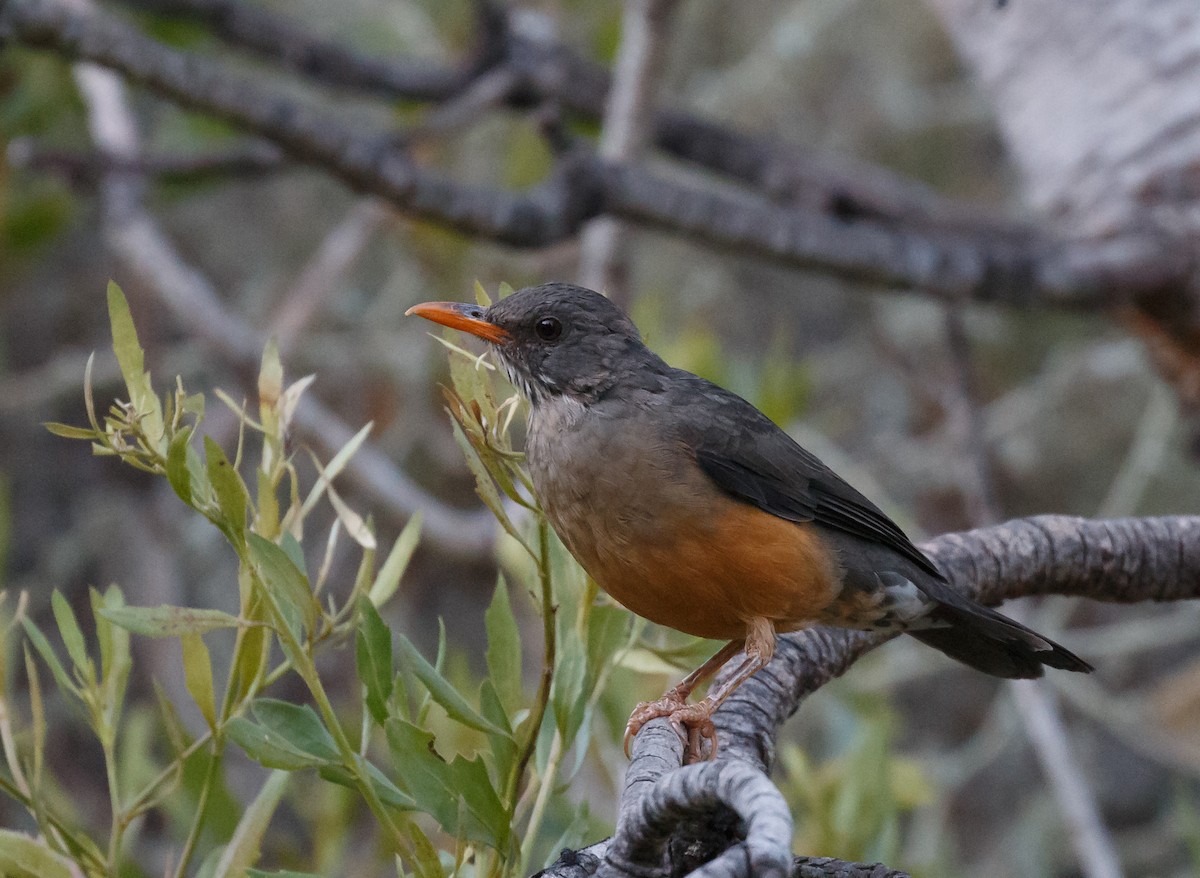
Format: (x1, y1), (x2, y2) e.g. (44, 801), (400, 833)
(564, 497), (841, 639)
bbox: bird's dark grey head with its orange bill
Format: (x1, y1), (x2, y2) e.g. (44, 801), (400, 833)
(408, 283), (665, 405)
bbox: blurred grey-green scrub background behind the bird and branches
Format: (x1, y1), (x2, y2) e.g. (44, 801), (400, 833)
(0, 0), (1200, 877)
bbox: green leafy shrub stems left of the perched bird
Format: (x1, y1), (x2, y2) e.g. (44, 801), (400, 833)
(0, 284), (640, 878)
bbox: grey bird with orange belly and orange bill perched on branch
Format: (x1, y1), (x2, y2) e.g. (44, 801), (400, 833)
(407, 283), (1092, 762)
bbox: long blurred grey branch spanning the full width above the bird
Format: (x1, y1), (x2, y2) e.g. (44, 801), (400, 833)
(0, 0), (1190, 308)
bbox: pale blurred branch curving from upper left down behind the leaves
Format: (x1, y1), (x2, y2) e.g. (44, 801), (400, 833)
(68, 58), (496, 558)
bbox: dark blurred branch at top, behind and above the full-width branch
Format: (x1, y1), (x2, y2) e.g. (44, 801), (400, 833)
(105, 0), (993, 233)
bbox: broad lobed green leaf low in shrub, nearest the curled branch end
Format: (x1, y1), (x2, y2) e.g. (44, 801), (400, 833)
(386, 718), (509, 848)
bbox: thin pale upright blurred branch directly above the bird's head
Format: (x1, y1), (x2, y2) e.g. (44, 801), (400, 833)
(578, 0), (677, 303)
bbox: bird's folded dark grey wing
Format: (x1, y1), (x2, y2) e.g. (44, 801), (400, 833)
(671, 373), (943, 579)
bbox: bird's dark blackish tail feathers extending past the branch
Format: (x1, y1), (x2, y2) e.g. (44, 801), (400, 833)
(908, 581), (1092, 679)
